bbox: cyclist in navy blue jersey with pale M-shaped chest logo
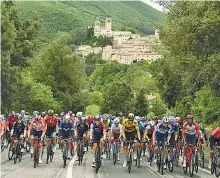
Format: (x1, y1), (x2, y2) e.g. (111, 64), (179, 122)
(60, 115), (73, 159)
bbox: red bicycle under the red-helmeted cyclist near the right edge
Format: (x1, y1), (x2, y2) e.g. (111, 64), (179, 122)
(183, 144), (195, 177)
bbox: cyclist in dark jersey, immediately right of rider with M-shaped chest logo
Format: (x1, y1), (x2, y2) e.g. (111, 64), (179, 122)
(74, 114), (89, 160)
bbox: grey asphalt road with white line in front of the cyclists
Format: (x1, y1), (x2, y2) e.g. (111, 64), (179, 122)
(1, 146), (214, 178)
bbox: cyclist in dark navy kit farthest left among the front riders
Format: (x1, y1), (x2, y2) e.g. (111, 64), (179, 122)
(11, 115), (27, 153)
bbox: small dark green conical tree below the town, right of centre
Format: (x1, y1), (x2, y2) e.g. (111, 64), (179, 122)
(134, 89), (149, 116)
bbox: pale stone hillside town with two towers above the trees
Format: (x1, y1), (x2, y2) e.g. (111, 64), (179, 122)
(77, 17), (163, 64)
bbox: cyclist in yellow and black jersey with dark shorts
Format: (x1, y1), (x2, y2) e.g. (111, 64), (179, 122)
(122, 113), (141, 167)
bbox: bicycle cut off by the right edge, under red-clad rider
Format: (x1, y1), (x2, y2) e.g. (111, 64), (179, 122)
(211, 145), (220, 177)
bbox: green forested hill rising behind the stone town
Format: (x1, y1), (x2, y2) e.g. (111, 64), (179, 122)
(17, 1), (165, 42)
